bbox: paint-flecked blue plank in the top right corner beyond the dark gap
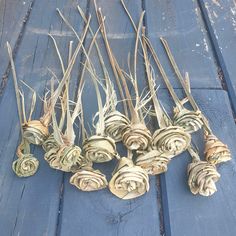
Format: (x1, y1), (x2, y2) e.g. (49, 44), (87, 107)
(199, 0), (236, 112)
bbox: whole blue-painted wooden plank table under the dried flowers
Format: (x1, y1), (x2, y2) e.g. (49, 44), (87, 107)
(0, 0), (236, 236)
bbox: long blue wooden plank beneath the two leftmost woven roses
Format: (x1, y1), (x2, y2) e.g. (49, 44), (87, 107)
(0, 0), (87, 236)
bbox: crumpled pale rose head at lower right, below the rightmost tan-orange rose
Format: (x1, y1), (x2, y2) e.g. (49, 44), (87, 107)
(188, 161), (220, 196)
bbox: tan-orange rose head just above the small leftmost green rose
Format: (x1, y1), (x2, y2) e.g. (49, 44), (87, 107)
(22, 120), (49, 145)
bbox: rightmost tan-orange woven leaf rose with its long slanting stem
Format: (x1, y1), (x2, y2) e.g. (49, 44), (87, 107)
(161, 38), (231, 164)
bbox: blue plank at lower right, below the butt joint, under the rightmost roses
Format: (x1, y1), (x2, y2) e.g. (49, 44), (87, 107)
(160, 89), (236, 236)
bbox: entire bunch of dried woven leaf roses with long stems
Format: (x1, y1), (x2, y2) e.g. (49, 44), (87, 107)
(7, 1), (231, 199)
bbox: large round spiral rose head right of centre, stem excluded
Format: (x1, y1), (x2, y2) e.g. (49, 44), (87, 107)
(152, 126), (191, 157)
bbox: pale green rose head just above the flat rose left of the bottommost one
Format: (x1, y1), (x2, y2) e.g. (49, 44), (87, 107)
(83, 135), (117, 163)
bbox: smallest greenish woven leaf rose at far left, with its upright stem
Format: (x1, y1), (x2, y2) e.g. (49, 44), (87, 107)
(7, 42), (39, 177)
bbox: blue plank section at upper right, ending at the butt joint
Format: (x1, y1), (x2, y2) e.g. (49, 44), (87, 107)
(144, 0), (221, 88)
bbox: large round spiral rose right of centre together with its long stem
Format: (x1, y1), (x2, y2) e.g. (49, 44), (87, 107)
(139, 29), (191, 158)
